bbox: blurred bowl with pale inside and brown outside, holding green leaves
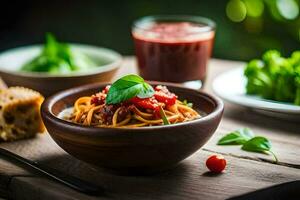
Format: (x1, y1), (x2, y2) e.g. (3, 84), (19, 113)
(0, 44), (122, 96)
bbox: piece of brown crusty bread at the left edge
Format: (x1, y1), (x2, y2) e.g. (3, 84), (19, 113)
(0, 87), (45, 141)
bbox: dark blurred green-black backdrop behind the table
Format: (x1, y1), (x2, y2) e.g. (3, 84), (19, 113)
(0, 0), (300, 60)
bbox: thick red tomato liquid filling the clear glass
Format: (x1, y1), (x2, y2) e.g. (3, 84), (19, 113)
(132, 22), (214, 83)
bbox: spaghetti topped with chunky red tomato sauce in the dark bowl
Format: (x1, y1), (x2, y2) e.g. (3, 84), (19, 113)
(68, 85), (200, 127)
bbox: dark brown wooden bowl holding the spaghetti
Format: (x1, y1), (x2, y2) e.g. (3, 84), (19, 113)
(41, 82), (224, 174)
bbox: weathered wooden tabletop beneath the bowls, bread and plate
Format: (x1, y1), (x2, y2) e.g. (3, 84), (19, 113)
(0, 57), (300, 200)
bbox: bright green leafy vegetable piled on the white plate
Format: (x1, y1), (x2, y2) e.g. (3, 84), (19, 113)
(244, 50), (300, 105)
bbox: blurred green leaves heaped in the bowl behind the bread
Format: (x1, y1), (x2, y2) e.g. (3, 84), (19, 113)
(21, 33), (97, 74)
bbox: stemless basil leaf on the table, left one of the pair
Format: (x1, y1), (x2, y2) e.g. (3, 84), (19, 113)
(218, 128), (254, 145)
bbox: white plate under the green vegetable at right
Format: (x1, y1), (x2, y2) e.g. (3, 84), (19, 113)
(212, 67), (300, 117)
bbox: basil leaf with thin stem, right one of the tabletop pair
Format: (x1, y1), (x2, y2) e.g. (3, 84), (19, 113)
(242, 136), (278, 162)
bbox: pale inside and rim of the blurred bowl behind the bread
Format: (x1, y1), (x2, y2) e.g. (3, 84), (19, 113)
(0, 43), (122, 78)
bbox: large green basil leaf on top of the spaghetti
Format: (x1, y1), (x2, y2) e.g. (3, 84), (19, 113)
(106, 74), (154, 104)
